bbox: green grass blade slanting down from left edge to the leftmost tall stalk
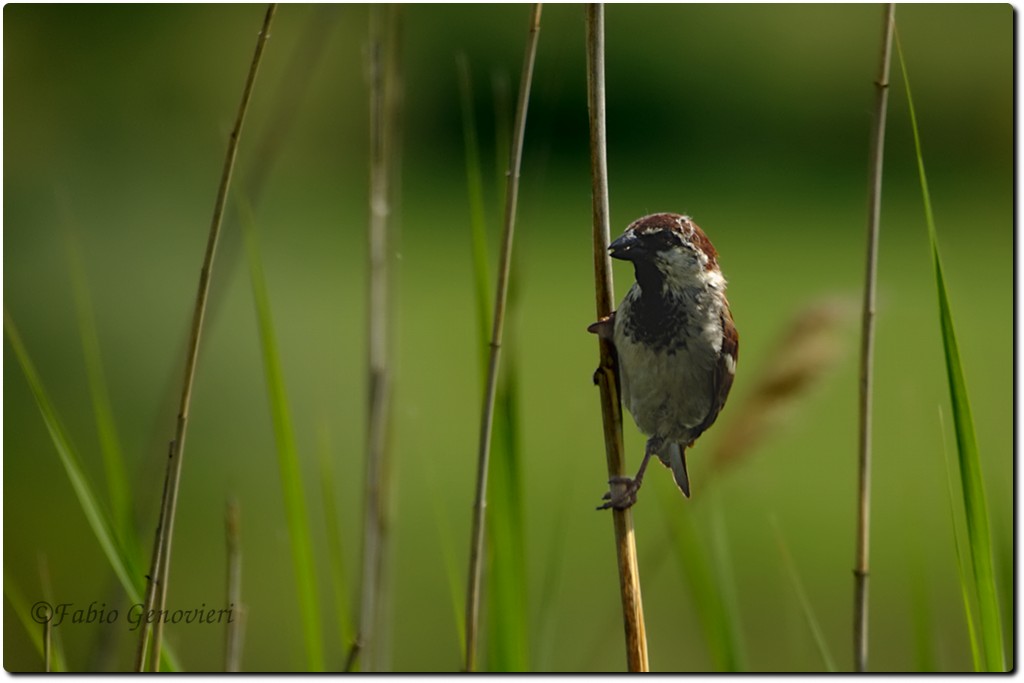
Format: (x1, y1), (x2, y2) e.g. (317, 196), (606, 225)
(3, 309), (140, 602)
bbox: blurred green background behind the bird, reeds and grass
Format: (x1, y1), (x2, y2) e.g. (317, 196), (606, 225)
(3, 4), (1014, 671)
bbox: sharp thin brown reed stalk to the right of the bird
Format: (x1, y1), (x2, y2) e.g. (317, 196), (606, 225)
(853, 3), (896, 673)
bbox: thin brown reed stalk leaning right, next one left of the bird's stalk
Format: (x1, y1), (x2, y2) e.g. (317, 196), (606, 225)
(466, 3), (541, 672)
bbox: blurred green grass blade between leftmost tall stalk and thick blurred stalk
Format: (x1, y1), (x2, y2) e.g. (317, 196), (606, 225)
(240, 203), (324, 672)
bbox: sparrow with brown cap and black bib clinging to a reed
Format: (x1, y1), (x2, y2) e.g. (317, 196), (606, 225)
(588, 213), (739, 510)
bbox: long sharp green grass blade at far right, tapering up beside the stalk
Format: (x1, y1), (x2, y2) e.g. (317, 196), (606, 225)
(897, 40), (1006, 672)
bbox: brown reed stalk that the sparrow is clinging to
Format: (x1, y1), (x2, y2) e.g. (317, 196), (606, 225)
(587, 4), (648, 672)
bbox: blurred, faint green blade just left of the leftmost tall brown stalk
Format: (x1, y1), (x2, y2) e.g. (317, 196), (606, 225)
(66, 227), (141, 557)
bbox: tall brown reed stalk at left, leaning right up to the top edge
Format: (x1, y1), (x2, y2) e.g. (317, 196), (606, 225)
(135, 4), (276, 672)
